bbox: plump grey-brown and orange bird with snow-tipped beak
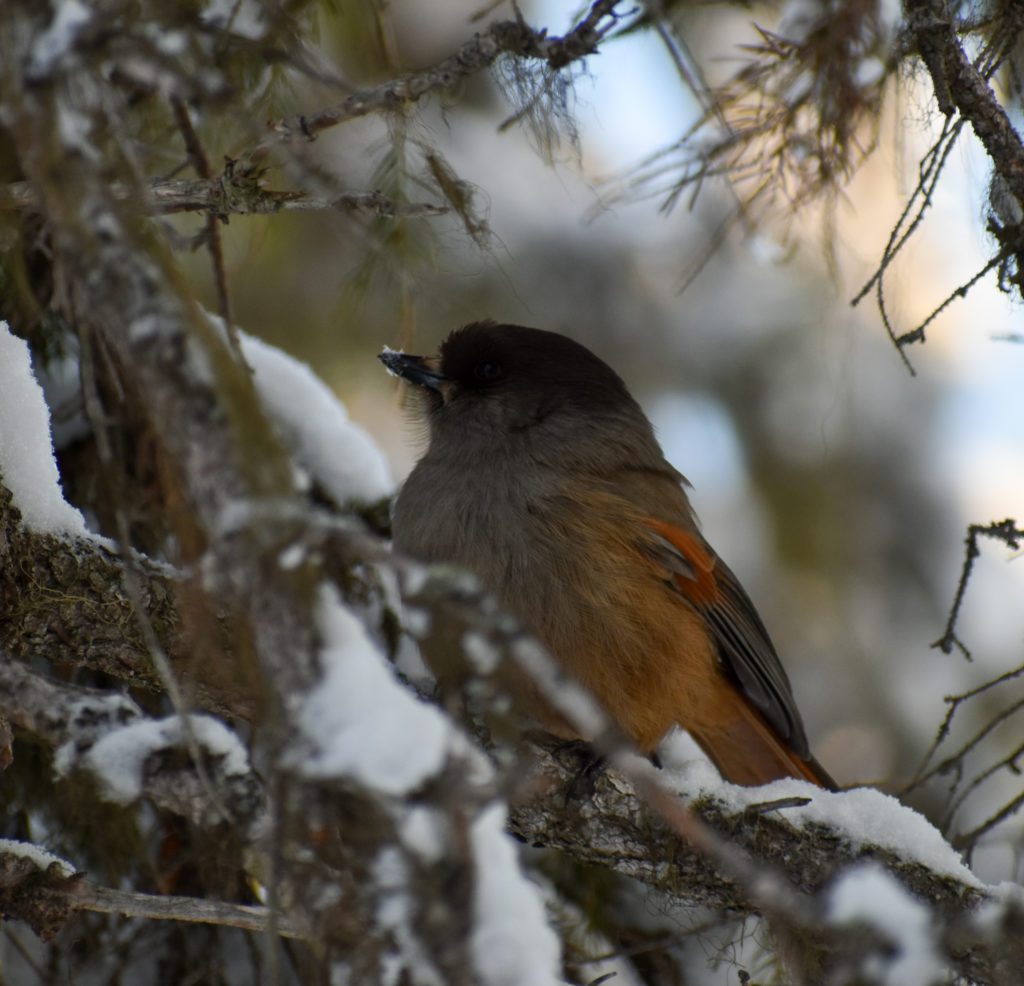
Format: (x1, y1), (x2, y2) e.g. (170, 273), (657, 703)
(379, 321), (836, 789)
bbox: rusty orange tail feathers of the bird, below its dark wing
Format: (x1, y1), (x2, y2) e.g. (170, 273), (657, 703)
(683, 692), (838, 790)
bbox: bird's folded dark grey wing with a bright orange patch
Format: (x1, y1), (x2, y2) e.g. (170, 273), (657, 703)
(644, 518), (809, 758)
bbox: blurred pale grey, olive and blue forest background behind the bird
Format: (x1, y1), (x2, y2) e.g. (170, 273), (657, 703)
(180, 0), (1024, 881)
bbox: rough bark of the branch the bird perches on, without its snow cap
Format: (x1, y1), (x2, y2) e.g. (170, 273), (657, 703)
(510, 742), (1024, 983)
